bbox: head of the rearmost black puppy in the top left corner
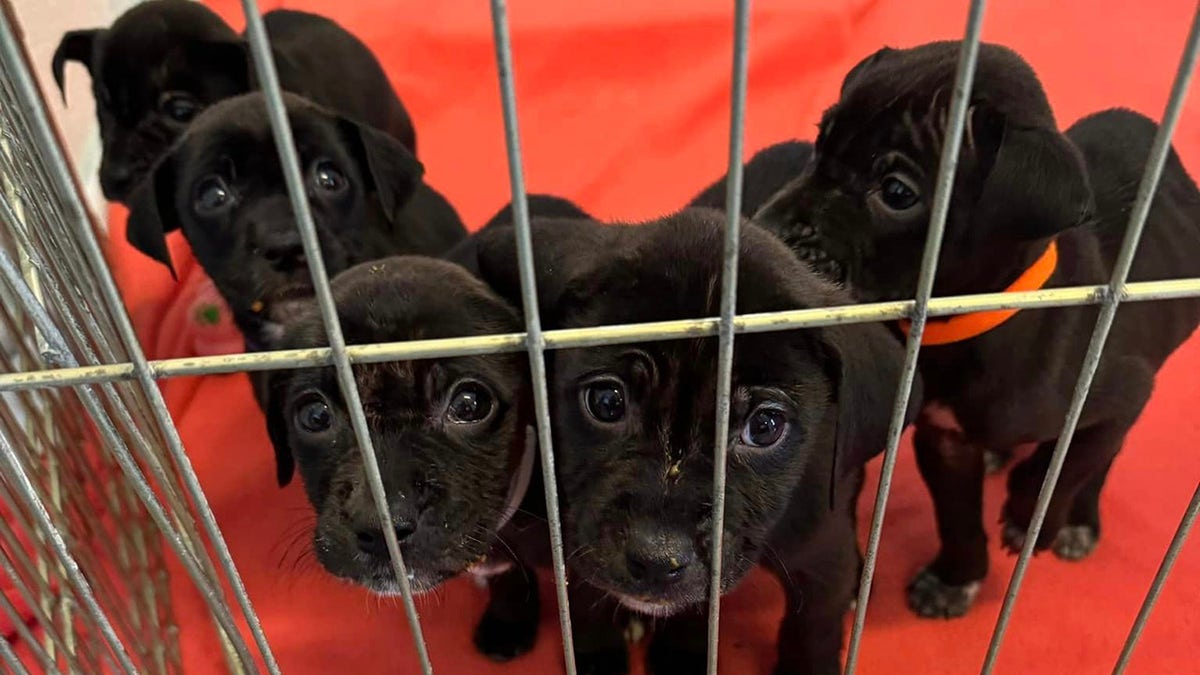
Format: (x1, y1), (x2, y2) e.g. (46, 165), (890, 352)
(52, 0), (251, 203)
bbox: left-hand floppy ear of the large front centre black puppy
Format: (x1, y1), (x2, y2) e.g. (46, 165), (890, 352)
(448, 219), (610, 323)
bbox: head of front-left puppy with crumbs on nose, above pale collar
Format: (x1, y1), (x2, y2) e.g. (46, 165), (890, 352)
(265, 257), (529, 593)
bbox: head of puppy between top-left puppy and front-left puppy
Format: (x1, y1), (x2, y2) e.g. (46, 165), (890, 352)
(127, 92), (424, 345)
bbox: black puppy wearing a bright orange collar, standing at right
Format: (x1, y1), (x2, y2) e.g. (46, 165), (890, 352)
(755, 42), (1200, 616)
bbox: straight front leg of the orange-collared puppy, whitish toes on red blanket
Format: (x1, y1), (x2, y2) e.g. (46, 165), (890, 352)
(908, 424), (988, 619)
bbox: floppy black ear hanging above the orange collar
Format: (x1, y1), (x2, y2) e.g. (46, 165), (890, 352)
(971, 106), (1096, 239)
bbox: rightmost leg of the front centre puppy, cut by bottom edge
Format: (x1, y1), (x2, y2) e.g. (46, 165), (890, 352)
(773, 519), (862, 675)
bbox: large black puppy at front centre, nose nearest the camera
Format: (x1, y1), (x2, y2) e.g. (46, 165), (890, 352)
(453, 209), (919, 674)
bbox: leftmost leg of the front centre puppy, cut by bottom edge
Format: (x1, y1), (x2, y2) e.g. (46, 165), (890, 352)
(568, 580), (629, 675)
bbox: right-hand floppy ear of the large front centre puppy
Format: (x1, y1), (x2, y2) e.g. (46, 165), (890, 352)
(822, 323), (924, 498)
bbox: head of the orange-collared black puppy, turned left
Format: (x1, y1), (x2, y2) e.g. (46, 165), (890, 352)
(755, 42), (1093, 299)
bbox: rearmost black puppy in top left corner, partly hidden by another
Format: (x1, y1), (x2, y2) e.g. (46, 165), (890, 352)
(52, 0), (416, 203)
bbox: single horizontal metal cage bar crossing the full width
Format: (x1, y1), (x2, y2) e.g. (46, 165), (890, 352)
(7, 277), (1200, 392)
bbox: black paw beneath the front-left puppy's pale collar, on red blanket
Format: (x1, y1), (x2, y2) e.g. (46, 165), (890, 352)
(475, 563), (540, 663)
